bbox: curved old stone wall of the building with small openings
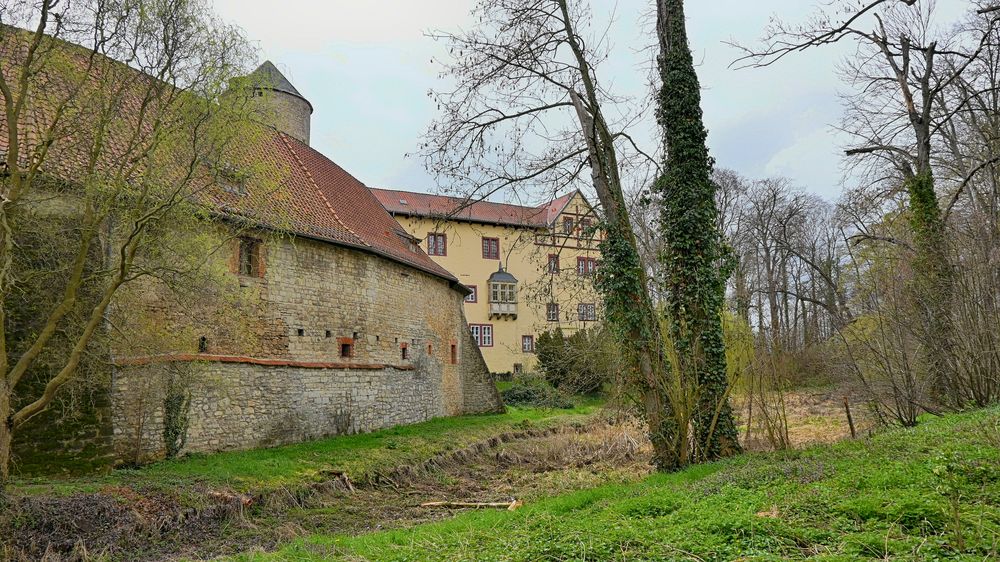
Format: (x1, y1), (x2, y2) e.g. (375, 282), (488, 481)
(112, 234), (503, 463)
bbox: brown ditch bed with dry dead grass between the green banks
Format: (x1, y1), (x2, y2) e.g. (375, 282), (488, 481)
(0, 390), (864, 562)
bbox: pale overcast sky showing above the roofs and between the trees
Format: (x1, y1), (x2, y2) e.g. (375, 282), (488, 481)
(215, 0), (965, 199)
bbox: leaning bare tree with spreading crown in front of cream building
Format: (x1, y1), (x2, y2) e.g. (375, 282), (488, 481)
(423, 0), (704, 469)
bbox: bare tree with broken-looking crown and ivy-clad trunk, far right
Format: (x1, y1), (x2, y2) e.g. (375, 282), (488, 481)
(737, 0), (1000, 406)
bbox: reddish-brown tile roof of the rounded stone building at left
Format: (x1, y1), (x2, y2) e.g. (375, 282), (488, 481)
(0, 28), (458, 283)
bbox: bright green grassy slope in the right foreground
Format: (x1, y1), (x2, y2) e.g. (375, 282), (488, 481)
(230, 410), (1000, 561)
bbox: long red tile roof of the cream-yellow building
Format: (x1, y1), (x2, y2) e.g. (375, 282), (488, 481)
(371, 188), (576, 228)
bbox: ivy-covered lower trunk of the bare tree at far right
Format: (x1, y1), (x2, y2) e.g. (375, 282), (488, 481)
(904, 167), (965, 408)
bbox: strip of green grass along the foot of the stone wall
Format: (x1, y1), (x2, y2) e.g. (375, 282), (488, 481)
(14, 400), (602, 495)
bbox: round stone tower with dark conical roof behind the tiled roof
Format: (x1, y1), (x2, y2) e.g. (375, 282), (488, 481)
(250, 61), (312, 144)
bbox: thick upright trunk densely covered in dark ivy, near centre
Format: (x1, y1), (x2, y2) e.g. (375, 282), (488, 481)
(655, 0), (741, 460)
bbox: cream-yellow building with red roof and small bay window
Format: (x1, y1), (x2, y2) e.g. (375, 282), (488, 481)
(372, 189), (601, 373)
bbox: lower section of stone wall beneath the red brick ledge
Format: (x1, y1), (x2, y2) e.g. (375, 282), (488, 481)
(114, 363), (444, 462)
